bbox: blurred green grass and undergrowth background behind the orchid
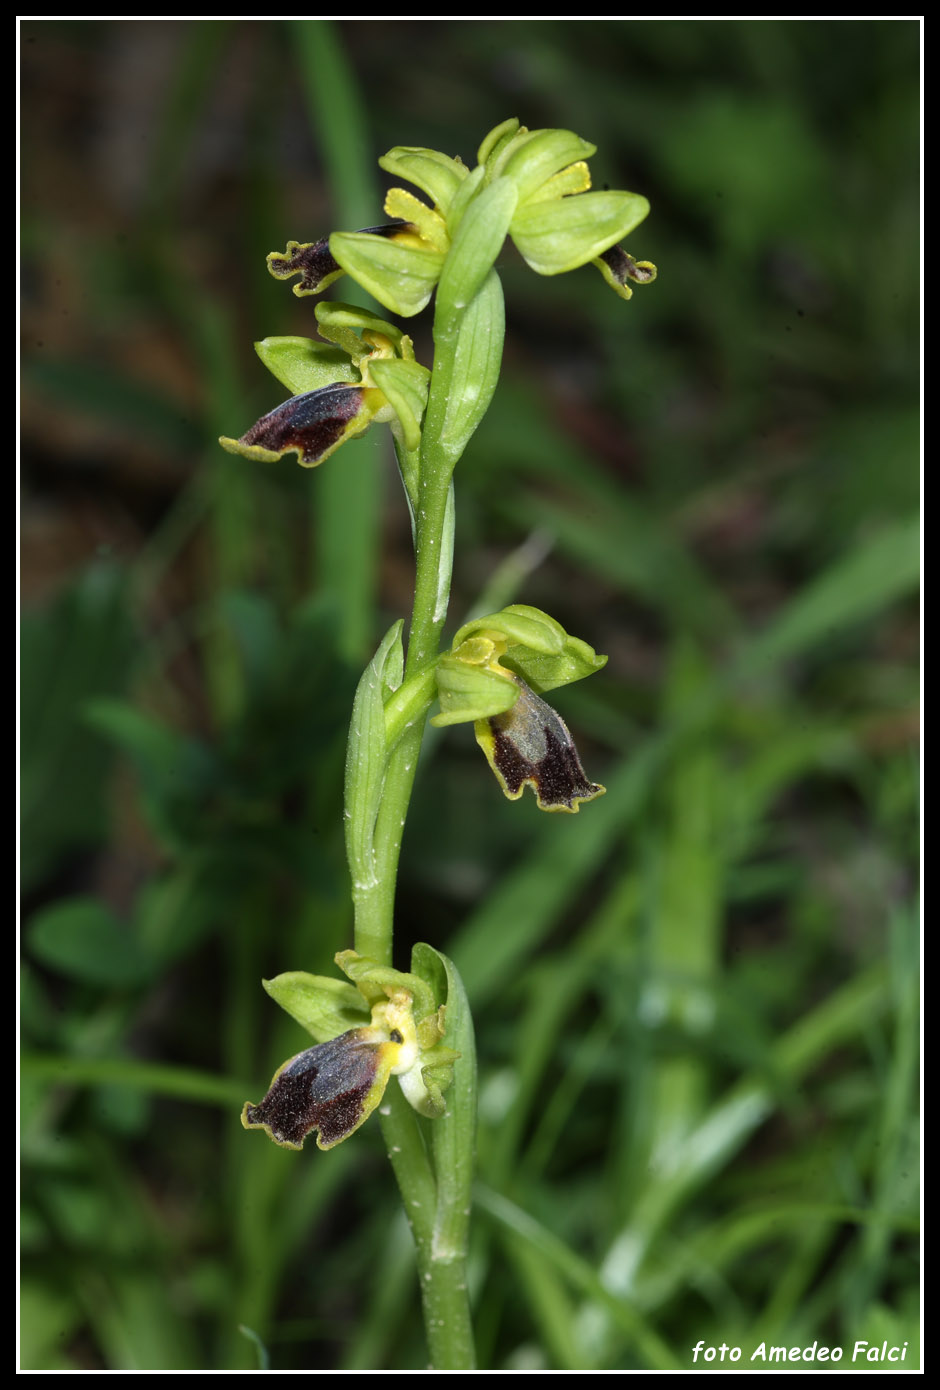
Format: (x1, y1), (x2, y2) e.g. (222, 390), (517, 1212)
(21, 21), (919, 1369)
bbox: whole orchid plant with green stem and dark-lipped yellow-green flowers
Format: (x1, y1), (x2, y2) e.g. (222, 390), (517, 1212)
(220, 120), (656, 1369)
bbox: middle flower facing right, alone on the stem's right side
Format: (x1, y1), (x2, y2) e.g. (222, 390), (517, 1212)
(431, 603), (606, 812)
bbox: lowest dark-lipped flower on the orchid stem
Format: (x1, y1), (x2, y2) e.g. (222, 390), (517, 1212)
(242, 948), (457, 1150)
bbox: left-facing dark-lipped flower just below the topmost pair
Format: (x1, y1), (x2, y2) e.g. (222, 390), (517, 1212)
(218, 303), (430, 468)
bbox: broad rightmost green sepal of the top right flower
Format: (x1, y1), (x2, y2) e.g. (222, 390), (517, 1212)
(509, 192), (649, 275)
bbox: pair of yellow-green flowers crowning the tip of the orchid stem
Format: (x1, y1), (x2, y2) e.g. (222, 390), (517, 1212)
(268, 118), (656, 317)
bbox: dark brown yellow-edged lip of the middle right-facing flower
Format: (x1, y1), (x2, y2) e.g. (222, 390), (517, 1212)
(474, 680), (605, 812)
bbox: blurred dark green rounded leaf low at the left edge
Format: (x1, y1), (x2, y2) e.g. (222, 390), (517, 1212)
(28, 898), (153, 988)
